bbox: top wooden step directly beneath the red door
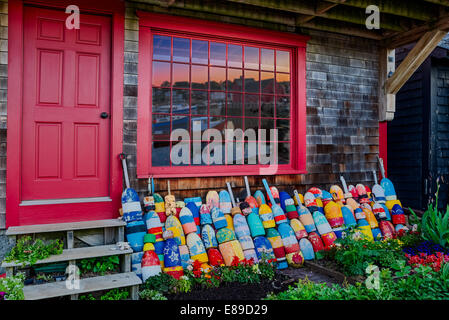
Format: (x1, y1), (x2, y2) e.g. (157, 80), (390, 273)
(5, 219), (126, 236)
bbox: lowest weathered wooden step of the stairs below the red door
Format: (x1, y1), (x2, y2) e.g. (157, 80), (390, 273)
(23, 272), (142, 300)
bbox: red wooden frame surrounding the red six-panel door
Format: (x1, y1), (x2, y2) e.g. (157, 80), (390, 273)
(6, 0), (125, 228)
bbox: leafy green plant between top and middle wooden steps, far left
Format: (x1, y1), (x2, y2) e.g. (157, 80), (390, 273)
(4, 236), (63, 266)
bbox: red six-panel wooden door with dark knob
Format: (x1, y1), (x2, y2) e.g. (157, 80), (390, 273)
(21, 7), (111, 202)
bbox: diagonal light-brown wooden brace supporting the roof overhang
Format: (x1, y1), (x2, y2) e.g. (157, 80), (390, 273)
(385, 30), (447, 94)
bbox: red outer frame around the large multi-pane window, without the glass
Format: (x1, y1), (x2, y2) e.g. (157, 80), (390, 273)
(137, 11), (310, 178)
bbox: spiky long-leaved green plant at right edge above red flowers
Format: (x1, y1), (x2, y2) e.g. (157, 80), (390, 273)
(410, 184), (449, 248)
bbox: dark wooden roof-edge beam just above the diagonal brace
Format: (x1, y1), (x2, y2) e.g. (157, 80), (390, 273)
(380, 14), (449, 48)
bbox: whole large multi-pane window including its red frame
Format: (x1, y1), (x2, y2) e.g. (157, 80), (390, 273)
(137, 13), (305, 177)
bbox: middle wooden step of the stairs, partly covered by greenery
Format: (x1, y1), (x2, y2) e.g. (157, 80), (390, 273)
(2, 244), (133, 268)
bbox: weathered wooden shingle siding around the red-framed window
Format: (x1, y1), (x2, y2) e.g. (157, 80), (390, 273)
(123, 2), (379, 199)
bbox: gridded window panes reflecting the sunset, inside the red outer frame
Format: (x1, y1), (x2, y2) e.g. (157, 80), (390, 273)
(152, 34), (291, 167)
